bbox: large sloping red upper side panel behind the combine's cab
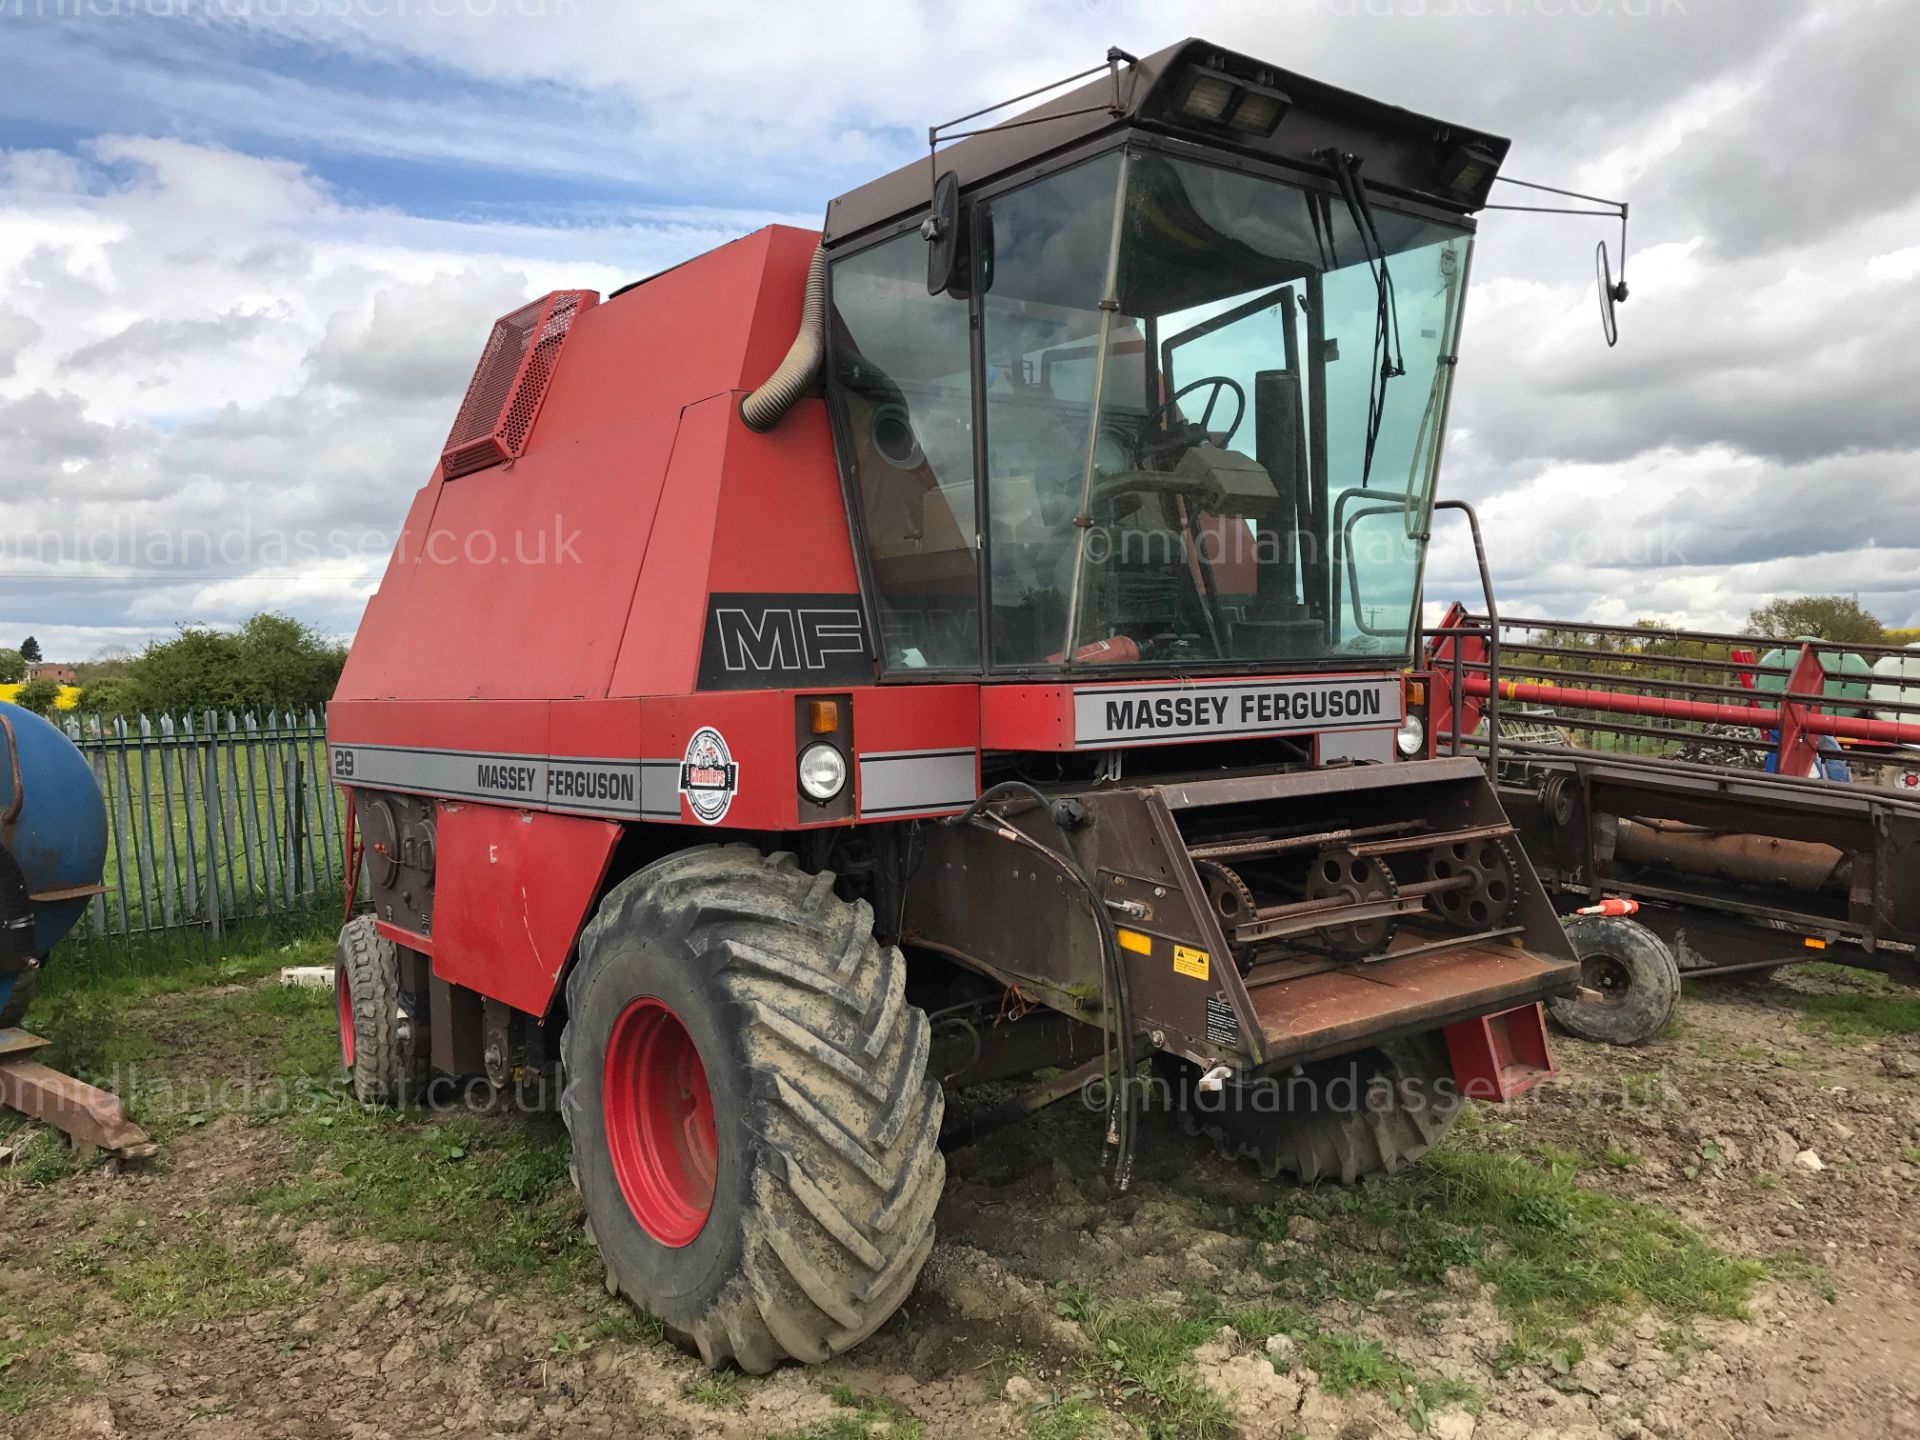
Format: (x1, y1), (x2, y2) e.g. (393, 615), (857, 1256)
(334, 227), (825, 701)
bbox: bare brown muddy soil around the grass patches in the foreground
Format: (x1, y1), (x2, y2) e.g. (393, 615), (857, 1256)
(0, 975), (1920, 1440)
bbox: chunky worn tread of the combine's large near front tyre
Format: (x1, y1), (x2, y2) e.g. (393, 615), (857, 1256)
(561, 845), (945, 1373)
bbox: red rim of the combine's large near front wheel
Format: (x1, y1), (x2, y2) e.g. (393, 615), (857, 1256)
(601, 996), (720, 1250)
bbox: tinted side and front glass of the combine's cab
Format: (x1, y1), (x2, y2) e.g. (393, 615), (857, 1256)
(831, 148), (1471, 670)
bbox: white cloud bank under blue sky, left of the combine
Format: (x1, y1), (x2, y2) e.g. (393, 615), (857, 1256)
(0, 129), (794, 660)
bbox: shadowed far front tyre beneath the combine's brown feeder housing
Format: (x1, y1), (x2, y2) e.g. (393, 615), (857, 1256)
(1162, 1031), (1459, 1185)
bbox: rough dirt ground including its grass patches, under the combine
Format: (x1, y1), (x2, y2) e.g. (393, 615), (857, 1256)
(0, 972), (1920, 1440)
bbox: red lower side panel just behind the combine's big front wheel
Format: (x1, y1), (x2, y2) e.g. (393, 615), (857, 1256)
(432, 804), (620, 1016)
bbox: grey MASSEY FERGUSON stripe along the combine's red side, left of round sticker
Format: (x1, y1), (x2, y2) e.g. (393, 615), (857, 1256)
(328, 745), (680, 820)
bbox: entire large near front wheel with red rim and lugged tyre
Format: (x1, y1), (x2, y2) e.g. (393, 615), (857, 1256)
(561, 845), (947, 1373)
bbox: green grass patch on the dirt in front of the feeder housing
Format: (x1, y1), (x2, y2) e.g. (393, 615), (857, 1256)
(1254, 1144), (1766, 1352)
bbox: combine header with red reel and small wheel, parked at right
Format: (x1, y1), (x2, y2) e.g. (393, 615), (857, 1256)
(1427, 589), (1920, 1044)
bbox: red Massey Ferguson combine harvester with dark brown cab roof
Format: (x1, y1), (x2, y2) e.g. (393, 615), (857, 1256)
(328, 42), (1578, 1371)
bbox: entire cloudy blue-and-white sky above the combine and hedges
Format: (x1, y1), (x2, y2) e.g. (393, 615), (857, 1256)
(0, 0), (1920, 659)
